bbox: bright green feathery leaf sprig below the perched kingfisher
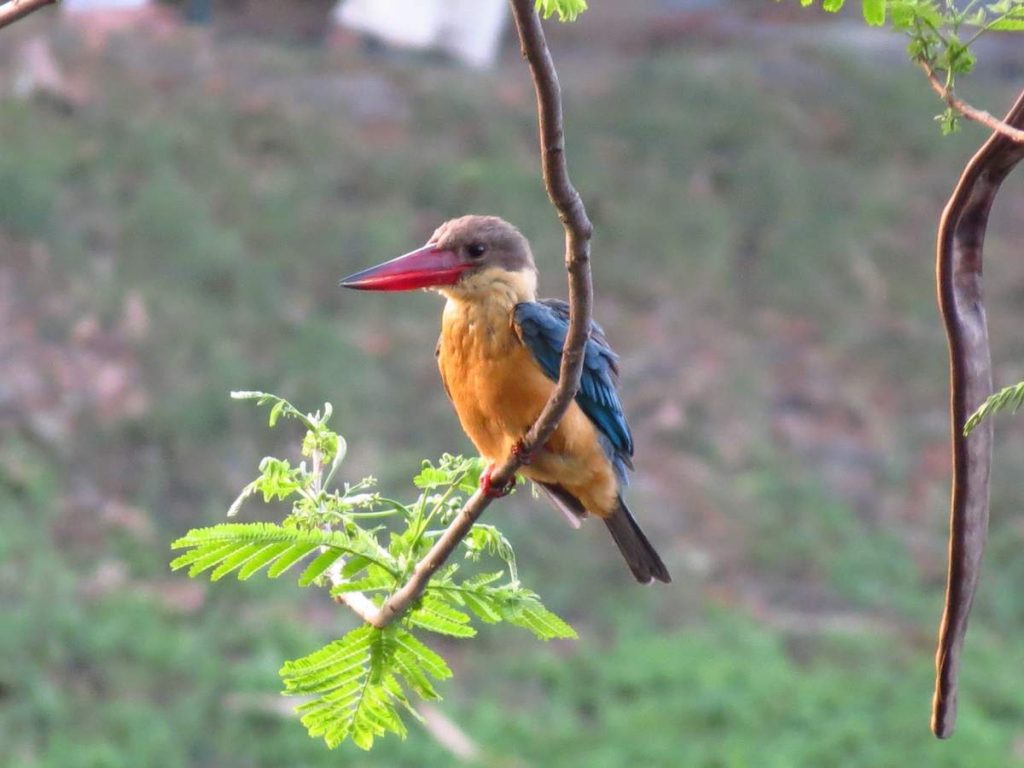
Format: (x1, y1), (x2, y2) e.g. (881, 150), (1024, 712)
(171, 392), (575, 750)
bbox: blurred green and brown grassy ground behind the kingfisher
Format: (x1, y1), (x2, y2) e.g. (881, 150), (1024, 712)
(0, 0), (1024, 768)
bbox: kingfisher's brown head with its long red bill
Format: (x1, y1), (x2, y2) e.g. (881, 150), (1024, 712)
(341, 216), (537, 300)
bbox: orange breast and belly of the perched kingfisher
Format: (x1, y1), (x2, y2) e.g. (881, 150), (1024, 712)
(438, 296), (617, 517)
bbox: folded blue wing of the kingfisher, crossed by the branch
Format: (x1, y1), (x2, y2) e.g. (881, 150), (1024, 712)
(512, 299), (633, 481)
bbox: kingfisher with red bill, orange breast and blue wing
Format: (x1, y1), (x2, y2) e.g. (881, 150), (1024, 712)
(341, 215), (672, 584)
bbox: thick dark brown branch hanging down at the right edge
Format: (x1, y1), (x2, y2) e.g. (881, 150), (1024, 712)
(932, 85), (1024, 738)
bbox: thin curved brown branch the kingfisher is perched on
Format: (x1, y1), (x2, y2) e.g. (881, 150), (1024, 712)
(331, 0), (593, 628)
